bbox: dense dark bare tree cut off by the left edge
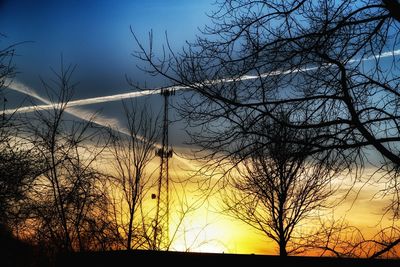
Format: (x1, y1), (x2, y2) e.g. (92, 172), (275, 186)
(0, 33), (40, 233)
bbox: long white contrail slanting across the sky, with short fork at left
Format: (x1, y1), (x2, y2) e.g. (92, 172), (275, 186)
(4, 49), (400, 114)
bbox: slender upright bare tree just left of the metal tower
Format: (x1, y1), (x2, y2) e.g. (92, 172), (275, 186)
(111, 101), (160, 250)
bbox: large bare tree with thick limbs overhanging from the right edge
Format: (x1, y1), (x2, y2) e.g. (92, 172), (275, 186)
(133, 0), (400, 258)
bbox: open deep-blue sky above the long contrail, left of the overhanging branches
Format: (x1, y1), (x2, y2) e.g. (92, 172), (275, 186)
(0, 0), (214, 98)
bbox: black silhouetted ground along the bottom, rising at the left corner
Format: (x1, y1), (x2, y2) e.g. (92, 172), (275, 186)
(0, 230), (400, 267)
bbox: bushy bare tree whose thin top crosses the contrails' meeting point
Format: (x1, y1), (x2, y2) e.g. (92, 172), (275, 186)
(22, 62), (108, 251)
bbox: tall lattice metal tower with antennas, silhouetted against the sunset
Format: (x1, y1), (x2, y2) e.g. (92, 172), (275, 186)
(153, 89), (175, 249)
